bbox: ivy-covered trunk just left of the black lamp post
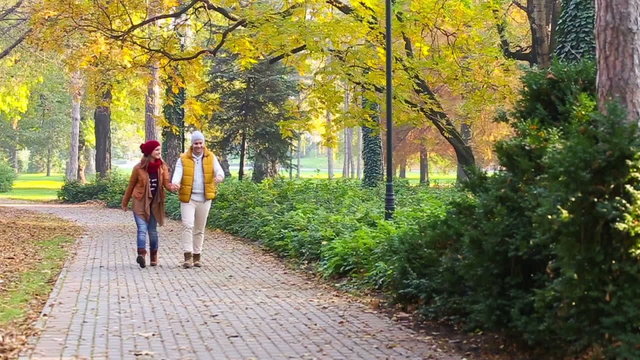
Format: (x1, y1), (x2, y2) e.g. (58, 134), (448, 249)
(362, 99), (384, 187)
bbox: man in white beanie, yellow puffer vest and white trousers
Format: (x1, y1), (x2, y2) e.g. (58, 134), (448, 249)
(171, 131), (224, 269)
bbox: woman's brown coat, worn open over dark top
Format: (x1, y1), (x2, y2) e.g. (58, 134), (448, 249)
(122, 163), (169, 226)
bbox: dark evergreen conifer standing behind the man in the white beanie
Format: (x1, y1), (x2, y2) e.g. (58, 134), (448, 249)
(210, 54), (298, 182)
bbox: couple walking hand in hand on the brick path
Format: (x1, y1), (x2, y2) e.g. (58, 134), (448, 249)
(122, 131), (224, 269)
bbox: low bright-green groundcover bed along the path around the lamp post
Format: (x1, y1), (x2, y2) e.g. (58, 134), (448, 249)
(195, 179), (458, 288)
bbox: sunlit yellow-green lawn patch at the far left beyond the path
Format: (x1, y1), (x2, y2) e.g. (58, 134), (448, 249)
(0, 174), (64, 201)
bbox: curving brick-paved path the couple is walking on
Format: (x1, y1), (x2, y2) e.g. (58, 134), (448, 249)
(12, 204), (462, 359)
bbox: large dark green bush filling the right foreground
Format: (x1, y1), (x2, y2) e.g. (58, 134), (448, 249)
(389, 62), (640, 359)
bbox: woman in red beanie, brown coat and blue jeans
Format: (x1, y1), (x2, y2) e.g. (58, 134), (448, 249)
(122, 140), (174, 268)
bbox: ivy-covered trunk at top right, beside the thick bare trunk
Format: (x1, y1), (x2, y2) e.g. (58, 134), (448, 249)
(555, 0), (596, 62)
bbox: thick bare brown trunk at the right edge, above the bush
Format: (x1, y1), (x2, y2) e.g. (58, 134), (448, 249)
(596, 0), (640, 122)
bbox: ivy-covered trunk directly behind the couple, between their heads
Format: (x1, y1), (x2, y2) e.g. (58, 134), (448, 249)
(162, 86), (186, 173)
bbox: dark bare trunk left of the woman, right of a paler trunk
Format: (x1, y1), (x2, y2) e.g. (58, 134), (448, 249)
(93, 88), (111, 178)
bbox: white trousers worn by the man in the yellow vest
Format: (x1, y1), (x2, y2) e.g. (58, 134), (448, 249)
(180, 200), (211, 254)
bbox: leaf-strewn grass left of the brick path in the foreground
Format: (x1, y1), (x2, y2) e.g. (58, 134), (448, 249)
(0, 207), (81, 359)
